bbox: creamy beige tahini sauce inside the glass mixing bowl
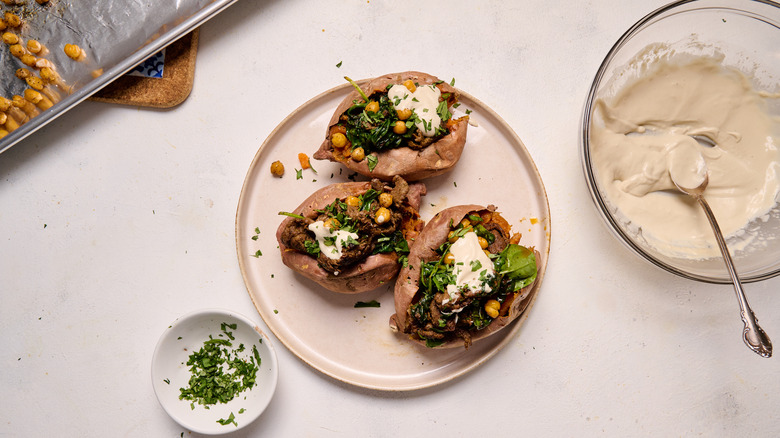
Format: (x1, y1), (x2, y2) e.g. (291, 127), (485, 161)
(591, 53), (780, 259)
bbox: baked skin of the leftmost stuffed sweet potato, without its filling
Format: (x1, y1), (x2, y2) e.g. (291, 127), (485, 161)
(276, 181), (426, 294)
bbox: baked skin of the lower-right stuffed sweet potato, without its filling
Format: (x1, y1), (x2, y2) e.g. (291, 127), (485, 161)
(390, 204), (540, 348)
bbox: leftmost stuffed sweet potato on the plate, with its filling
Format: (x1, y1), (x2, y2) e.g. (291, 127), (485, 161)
(276, 177), (426, 293)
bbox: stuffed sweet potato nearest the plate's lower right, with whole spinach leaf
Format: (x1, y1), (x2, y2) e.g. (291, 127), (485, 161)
(390, 205), (538, 348)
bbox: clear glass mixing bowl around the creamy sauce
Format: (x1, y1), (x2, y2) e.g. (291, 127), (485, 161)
(580, 0), (780, 283)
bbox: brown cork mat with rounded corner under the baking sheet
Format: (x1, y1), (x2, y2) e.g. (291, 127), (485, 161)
(89, 29), (198, 108)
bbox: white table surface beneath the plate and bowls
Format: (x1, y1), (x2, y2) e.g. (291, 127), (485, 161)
(0, 0), (780, 437)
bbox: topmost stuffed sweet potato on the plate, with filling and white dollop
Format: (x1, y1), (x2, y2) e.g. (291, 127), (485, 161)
(314, 71), (468, 181)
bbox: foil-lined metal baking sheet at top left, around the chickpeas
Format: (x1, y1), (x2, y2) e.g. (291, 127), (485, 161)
(0, 0), (237, 152)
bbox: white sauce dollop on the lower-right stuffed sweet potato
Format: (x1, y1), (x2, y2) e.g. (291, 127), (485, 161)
(447, 231), (495, 300)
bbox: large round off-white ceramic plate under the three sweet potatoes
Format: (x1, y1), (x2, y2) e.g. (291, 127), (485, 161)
(236, 84), (550, 390)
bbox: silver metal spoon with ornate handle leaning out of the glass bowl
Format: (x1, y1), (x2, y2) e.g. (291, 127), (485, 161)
(672, 174), (772, 357)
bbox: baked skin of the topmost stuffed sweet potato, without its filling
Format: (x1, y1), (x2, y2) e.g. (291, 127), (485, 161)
(313, 71), (468, 181)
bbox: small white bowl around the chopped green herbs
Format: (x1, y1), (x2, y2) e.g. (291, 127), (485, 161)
(152, 309), (279, 435)
